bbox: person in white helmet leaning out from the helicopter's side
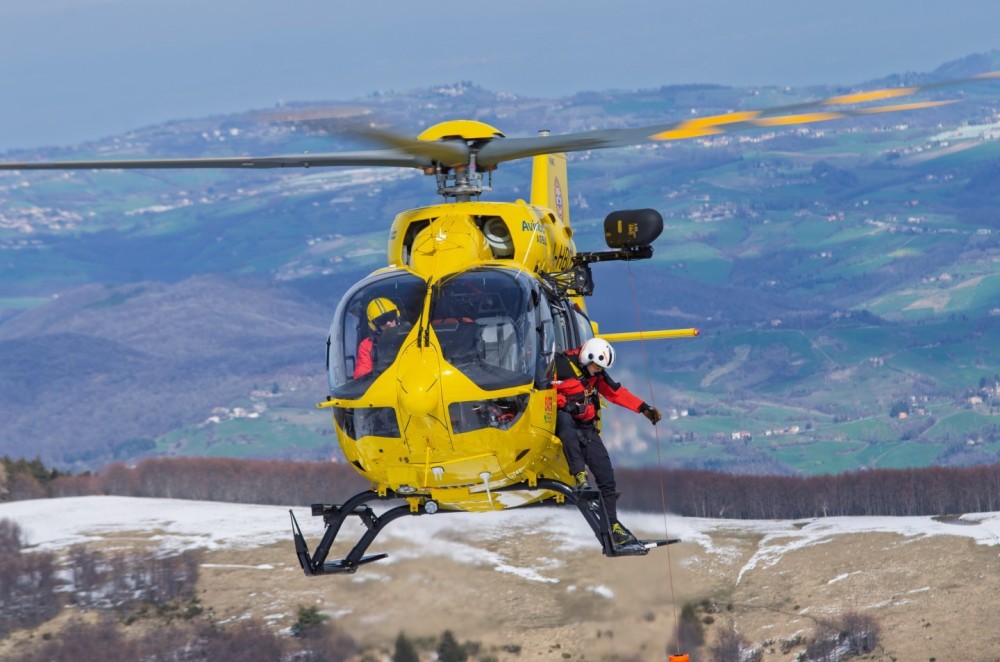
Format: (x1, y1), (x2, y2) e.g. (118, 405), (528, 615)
(553, 338), (661, 547)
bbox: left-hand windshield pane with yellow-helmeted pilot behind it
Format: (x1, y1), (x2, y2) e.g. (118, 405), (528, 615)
(327, 271), (427, 399)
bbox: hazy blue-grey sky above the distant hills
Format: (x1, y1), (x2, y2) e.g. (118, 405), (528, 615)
(0, 0), (1000, 151)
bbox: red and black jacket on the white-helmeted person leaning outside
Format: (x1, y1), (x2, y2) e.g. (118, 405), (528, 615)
(552, 349), (645, 421)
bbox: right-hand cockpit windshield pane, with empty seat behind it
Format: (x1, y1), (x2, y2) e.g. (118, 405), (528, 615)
(431, 268), (552, 391)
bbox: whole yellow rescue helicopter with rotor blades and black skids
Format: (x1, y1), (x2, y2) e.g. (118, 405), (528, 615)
(0, 72), (1000, 575)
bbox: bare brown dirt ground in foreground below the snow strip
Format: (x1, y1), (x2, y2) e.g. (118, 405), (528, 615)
(0, 523), (1000, 662)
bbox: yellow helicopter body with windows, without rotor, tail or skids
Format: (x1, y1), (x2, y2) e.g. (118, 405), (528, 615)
(321, 201), (593, 511)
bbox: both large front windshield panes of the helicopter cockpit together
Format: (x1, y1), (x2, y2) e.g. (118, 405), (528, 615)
(327, 267), (565, 400)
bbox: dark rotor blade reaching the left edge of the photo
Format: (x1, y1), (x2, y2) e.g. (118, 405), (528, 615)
(0, 149), (433, 170)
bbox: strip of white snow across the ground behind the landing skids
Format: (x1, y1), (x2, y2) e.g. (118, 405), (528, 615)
(0, 496), (1000, 581)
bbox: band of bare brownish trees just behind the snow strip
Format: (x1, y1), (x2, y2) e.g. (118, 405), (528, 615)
(7, 458), (1000, 519)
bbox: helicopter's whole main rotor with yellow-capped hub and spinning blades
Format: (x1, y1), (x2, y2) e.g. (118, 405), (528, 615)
(0, 71), (1000, 199)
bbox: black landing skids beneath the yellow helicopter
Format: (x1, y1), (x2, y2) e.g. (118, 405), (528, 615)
(288, 479), (680, 576)
